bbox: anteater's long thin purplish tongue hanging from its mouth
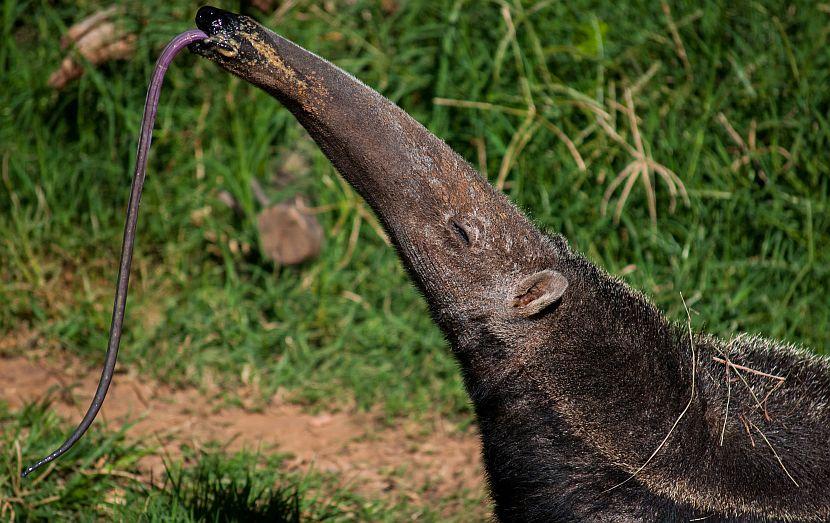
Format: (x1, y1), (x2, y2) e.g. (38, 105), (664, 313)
(20, 29), (208, 478)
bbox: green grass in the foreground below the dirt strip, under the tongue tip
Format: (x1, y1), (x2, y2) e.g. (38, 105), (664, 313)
(0, 401), (456, 523)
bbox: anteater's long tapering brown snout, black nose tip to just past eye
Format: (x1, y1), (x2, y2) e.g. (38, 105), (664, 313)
(191, 7), (538, 299)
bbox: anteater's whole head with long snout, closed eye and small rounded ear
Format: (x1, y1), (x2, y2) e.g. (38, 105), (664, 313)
(191, 7), (574, 373)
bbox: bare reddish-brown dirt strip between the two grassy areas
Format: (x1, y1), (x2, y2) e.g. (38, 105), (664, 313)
(0, 331), (488, 516)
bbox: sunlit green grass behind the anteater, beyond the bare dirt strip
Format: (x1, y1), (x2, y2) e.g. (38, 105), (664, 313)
(0, 0), (830, 520)
